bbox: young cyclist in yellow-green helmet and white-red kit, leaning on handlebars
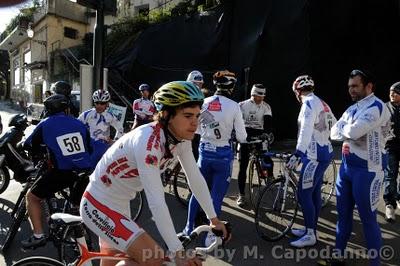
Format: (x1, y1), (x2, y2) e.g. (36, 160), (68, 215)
(80, 81), (228, 266)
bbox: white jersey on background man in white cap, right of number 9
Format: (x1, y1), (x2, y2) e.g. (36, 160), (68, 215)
(239, 99), (272, 130)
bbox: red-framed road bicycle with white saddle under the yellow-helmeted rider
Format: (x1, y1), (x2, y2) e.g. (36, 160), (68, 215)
(13, 213), (231, 266)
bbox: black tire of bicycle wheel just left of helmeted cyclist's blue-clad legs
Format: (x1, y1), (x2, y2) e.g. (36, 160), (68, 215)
(254, 178), (299, 242)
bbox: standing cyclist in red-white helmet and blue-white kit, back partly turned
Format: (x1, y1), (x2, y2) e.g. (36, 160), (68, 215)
(287, 75), (336, 248)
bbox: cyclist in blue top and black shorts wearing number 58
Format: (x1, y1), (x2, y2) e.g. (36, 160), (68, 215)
(21, 94), (92, 248)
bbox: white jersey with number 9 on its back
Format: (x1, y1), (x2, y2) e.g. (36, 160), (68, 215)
(197, 95), (247, 147)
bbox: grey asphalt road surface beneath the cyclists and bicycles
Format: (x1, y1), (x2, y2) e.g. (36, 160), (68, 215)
(0, 101), (400, 266)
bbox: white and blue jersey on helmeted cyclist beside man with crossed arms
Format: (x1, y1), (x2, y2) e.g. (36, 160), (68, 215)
(296, 93), (336, 161)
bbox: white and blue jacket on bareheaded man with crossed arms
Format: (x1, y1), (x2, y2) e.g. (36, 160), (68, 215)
(331, 94), (391, 171)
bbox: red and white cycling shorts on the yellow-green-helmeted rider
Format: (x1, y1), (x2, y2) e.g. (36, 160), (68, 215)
(80, 191), (145, 253)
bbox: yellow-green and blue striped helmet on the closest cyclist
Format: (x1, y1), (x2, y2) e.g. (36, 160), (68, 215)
(153, 81), (204, 111)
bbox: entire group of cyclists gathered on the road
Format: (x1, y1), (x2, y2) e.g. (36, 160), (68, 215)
(1, 67), (400, 266)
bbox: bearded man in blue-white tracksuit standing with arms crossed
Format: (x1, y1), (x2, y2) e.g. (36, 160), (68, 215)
(331, 70), (390, 266)
